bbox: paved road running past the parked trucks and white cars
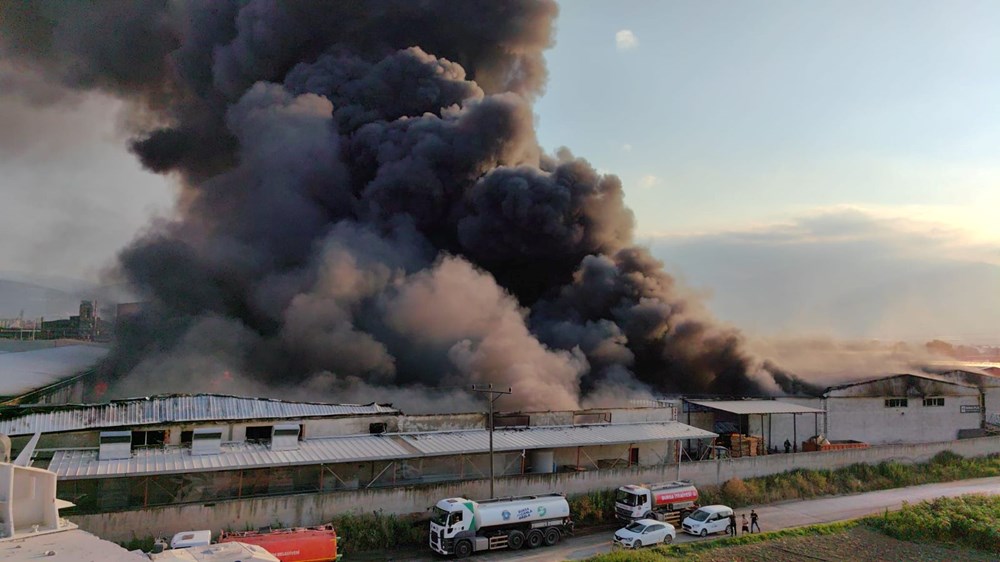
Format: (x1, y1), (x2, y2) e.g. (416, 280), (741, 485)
(391, 478), (1000, 562)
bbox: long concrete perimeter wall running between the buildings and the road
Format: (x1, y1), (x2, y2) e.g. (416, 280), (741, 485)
(70, 437), (1000, 541)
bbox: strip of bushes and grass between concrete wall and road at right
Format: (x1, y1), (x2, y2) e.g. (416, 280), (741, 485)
(698, 451), (1000, 507)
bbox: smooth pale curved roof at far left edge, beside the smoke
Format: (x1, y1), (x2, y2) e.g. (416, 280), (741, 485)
(0, 344), (108, 396)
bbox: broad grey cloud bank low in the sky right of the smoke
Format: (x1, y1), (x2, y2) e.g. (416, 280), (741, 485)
(649, 207), (1000, 342)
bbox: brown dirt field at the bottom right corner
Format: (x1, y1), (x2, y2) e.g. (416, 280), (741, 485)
(692, 527), (997, 562)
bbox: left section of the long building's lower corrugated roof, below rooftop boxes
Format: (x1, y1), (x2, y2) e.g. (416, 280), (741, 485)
(49, 435), (416, 474)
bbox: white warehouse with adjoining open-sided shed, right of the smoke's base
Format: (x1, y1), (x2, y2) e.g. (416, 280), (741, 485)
(679, 371), (1000, 452)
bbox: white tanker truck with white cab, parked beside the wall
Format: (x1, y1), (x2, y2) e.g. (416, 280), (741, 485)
(430, 494), (573, 558)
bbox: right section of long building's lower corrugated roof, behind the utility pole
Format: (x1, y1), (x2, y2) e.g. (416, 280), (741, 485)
(400, 422), (717, 455)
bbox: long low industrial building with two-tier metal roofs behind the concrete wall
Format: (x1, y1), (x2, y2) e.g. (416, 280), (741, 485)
(0, 395), (716, 514)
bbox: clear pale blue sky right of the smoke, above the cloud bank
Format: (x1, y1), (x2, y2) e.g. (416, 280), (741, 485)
(536, 0), (1000, 239)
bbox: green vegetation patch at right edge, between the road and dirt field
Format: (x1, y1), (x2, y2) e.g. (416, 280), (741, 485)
(864, 496), (1000, 553)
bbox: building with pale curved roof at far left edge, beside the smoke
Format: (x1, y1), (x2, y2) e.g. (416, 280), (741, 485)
(0, 340), (108, 406)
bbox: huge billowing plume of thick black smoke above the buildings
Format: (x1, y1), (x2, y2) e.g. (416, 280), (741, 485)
(0, 0), (761, 409)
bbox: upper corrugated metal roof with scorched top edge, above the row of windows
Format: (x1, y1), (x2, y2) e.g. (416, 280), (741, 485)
(0, 394), (399, 435)
